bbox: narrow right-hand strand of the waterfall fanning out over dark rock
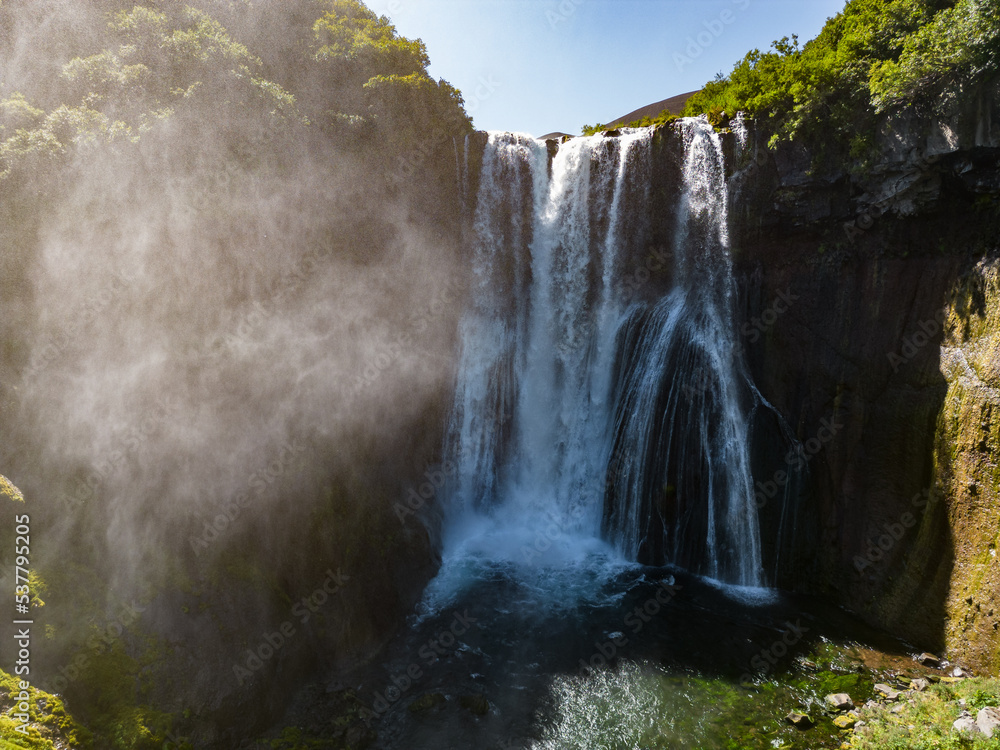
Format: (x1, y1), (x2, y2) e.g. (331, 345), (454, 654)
(605, 119), (763, 586)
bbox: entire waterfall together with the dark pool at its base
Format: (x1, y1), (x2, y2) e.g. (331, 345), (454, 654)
(364, 120), (904, 750)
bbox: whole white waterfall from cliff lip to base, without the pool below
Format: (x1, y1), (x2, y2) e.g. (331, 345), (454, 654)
(445, 120), (761, 585)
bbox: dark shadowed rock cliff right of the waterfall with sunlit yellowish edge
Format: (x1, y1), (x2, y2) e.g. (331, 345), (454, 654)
(734, 78), (1000, 672)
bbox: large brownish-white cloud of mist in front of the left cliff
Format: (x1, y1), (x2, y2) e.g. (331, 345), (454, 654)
(0, 0), (468, 740)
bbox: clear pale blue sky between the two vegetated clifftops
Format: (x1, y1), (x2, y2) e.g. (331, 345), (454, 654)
(366, 0), (846, 135)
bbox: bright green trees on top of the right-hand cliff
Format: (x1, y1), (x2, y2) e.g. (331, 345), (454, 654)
(683, 0), (1000, 158)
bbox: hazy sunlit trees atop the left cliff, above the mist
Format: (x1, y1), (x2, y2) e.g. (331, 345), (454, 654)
(0, 0), (471, 178)
